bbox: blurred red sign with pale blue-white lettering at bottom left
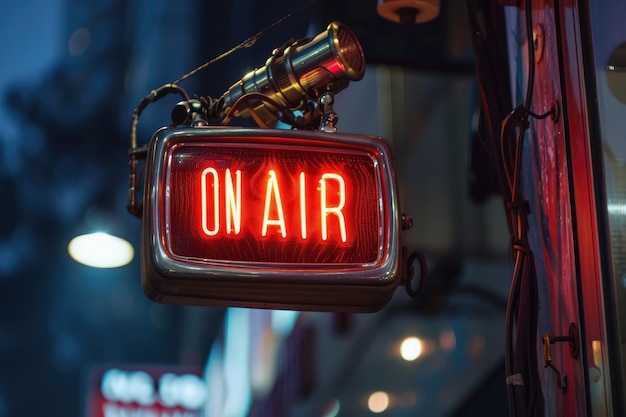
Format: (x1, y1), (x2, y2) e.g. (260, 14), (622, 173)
(86, 366), (208, 417)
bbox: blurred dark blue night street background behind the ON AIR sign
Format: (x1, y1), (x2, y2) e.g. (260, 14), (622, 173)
(0, 0), (512, 417)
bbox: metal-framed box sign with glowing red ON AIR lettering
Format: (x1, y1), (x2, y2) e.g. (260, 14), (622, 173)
(142, 127), (400, 311)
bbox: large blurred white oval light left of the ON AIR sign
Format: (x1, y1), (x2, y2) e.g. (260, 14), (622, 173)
(67, 232), (135, 268)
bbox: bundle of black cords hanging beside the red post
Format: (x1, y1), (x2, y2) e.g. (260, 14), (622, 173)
(500, 0), (552, 417)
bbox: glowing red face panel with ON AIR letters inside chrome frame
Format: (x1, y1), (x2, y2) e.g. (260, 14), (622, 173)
(163, 142), (383, 264)
